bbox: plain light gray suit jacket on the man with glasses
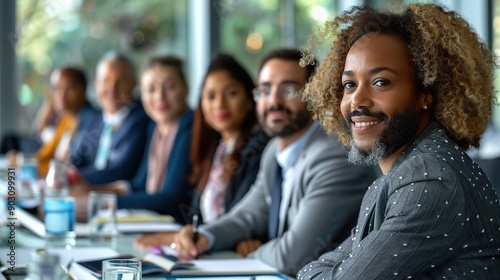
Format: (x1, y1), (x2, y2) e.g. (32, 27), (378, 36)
(204, 124), (375, 275)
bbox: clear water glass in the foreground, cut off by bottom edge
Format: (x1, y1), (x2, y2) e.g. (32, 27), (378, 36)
(102, 259), (142, 280)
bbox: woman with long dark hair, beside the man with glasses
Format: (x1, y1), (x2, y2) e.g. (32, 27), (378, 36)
(136, 54), (269, 247)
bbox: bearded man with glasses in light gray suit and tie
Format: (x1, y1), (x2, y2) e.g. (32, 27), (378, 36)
(175, 49), (375, 275)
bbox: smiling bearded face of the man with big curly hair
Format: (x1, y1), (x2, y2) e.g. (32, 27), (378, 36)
(341, 33), (425, 165)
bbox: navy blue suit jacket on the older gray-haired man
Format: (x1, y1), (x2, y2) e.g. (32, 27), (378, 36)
(70, 100), (149, 185)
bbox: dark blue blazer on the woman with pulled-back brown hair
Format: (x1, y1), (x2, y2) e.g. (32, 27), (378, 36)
(118, 110), (193, 222)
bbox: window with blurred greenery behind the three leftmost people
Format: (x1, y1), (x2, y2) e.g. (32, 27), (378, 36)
(16, 0), (188, 124)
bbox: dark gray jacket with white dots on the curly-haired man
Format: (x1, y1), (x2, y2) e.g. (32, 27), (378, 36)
(297, 123), (500, 280)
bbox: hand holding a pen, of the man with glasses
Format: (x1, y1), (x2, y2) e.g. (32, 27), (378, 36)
(172, 225), (208, 258)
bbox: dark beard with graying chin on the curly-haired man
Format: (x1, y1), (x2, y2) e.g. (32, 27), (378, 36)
(341, 108), (418, 166)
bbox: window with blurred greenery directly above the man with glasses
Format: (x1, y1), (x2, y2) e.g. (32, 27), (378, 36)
(219, 0), (336, 76)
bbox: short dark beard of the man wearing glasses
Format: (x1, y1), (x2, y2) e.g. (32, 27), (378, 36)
(259, 106), (311, 137)
